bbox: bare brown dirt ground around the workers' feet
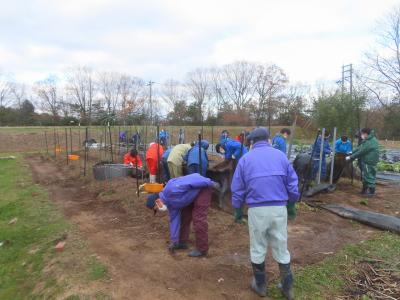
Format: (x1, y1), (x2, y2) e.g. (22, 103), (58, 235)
(27, 155), (400, 299)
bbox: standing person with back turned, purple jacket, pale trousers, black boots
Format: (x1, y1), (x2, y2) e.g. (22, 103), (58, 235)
(231, 128), (299, 299)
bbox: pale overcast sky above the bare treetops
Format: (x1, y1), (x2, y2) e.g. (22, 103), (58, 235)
(0, 0), (399, 83)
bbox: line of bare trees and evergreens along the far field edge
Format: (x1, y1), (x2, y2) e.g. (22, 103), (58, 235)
(0, 8), (400, 138)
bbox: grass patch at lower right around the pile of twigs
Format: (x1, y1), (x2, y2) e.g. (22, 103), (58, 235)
(270, 233), (400, 300)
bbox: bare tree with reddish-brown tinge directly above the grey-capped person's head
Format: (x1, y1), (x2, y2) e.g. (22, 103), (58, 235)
(254, 64), (288, 127)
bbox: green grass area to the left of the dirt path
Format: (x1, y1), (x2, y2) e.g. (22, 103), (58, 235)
(0, 156), (107, 300)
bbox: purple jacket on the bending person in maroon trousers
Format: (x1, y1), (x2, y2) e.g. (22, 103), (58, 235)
(160, 173), (214, 243)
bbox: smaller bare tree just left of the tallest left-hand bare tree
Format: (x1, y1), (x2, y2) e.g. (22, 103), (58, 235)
(33, 77), (60, 123)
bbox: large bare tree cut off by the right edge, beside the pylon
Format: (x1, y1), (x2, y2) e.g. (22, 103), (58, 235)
(362, 6), (400, 108)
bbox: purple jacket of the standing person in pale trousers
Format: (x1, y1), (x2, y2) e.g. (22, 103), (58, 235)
(231, 142), (299, 208)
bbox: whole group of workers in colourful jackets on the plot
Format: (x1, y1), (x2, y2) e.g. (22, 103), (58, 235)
(125, 128), (378, 299)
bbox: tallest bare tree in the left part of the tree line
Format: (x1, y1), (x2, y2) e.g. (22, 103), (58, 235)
(67, 67), (95, 125)
